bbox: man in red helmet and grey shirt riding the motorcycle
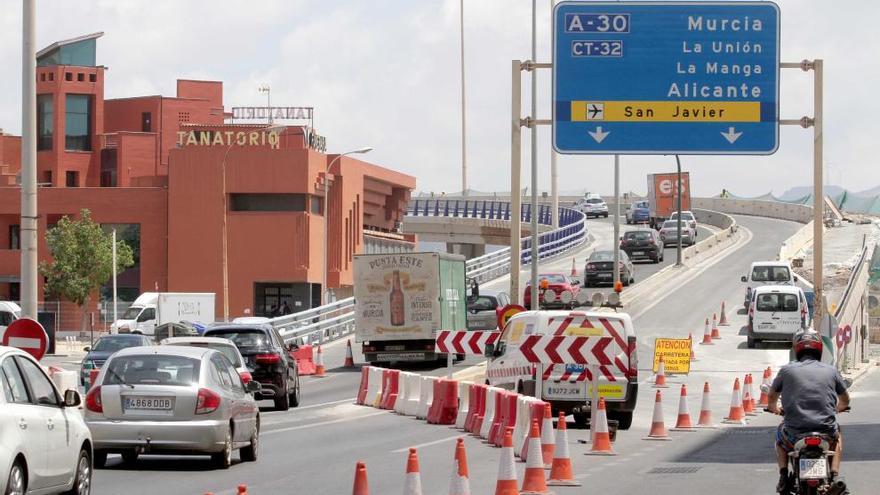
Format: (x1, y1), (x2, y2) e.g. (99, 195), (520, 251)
(767, 331), (849, 493)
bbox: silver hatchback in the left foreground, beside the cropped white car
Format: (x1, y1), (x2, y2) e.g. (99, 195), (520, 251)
(84, 346), (260, 469)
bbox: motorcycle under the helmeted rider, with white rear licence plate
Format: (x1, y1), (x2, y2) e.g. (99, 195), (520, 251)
(764, 408), (849, 495)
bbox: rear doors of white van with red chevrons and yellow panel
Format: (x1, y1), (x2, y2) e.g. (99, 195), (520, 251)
(541, 311), (635, 401)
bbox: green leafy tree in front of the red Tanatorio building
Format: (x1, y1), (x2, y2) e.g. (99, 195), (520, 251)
(40, 208), (134, 330)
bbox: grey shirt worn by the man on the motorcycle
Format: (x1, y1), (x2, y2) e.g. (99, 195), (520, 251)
(771, 359), (846, 433)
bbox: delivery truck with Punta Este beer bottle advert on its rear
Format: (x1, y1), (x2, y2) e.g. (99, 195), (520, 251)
(354, 253), (467, 364)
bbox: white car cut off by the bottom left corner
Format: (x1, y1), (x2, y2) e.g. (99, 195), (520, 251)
(0, 346), (92, 495)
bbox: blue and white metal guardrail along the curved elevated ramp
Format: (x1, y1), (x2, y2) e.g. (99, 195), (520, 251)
(269, 200), (589, 345)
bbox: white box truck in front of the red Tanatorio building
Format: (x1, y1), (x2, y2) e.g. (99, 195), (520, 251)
(110, 292), (215, 335)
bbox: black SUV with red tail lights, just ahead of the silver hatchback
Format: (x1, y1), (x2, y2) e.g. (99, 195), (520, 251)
(204, 324), (299, 411)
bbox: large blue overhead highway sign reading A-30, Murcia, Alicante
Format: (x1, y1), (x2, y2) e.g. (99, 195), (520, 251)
(553, 1), (779, 155)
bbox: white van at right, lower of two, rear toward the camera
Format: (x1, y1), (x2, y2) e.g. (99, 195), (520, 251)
(747, 285), (808, 349)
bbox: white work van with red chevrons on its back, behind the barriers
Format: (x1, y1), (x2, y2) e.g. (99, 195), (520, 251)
(486, 311), (639, 429)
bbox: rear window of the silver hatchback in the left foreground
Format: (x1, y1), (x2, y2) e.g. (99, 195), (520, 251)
(104, 354), (200, 387)
